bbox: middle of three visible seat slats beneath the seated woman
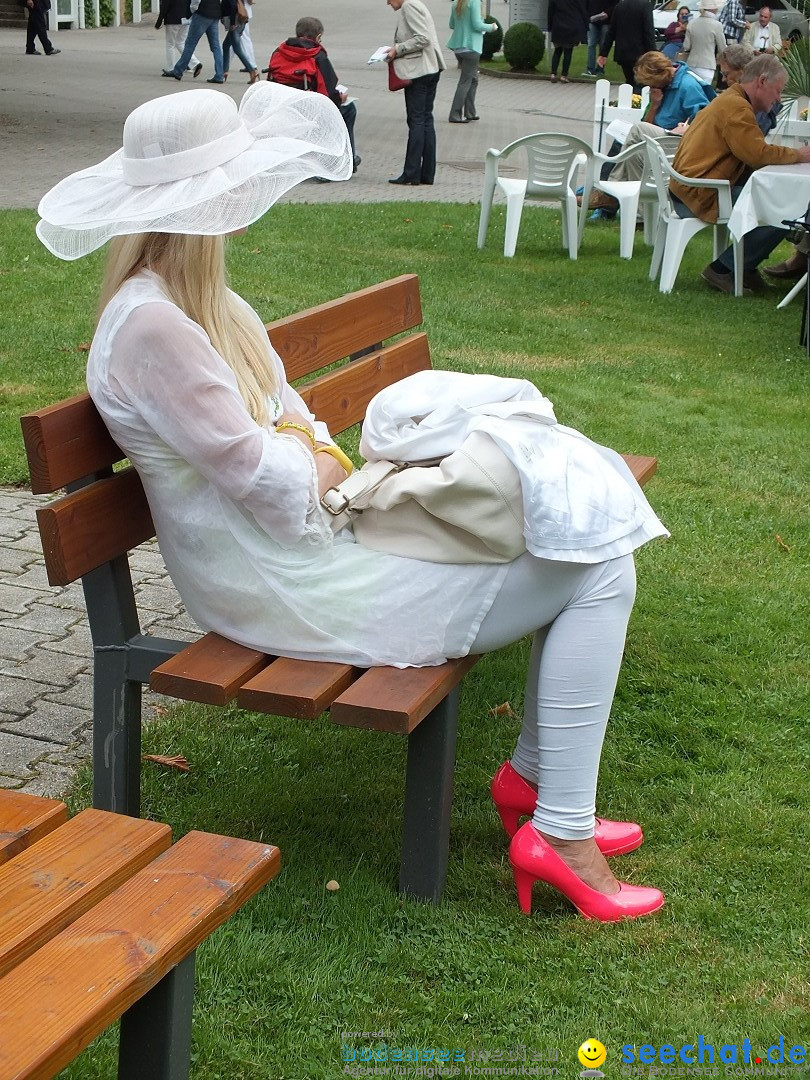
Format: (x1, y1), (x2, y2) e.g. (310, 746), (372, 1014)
(237, 657), (360, 720)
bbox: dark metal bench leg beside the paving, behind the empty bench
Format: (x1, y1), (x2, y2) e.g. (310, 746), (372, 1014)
(93, 647), (140, 818)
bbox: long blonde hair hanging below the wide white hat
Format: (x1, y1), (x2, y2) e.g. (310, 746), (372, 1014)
(99, 232), (280, 427)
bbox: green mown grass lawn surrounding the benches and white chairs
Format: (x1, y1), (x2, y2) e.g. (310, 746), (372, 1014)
(0, 204), (810, 1080)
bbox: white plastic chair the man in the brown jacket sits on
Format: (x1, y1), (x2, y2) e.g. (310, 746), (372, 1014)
(644, 135), (742, 296)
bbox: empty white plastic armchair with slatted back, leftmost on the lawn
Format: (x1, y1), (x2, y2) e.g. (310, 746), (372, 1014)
(478, 132), (593, 259)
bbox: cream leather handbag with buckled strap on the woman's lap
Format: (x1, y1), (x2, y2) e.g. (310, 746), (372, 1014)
(321, 431), (526, 563)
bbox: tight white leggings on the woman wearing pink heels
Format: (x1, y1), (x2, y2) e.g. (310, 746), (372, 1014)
(470, 553), (636, 840)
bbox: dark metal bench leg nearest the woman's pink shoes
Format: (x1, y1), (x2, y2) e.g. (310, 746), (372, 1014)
(400, 687), (459, 904)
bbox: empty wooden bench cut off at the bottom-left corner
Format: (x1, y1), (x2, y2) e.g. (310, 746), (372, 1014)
(0, 791), (281, 1080)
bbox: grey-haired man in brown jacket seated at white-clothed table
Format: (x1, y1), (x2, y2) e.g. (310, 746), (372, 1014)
(670, 56), (810, 293)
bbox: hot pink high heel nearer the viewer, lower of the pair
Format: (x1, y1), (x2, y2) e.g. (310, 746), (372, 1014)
(509, 821), (664, 922)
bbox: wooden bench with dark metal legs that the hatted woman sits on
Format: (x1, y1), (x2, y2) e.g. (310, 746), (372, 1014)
(22, 274), (657, 901)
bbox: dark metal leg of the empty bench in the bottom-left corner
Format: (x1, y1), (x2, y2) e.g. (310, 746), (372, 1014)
(118, 953), (194, 1080)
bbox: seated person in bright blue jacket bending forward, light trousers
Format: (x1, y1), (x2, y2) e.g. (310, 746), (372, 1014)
(589, 51), (715, 215)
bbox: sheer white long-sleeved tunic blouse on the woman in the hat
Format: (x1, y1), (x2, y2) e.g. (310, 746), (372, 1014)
(87, 271), (507, 667)
